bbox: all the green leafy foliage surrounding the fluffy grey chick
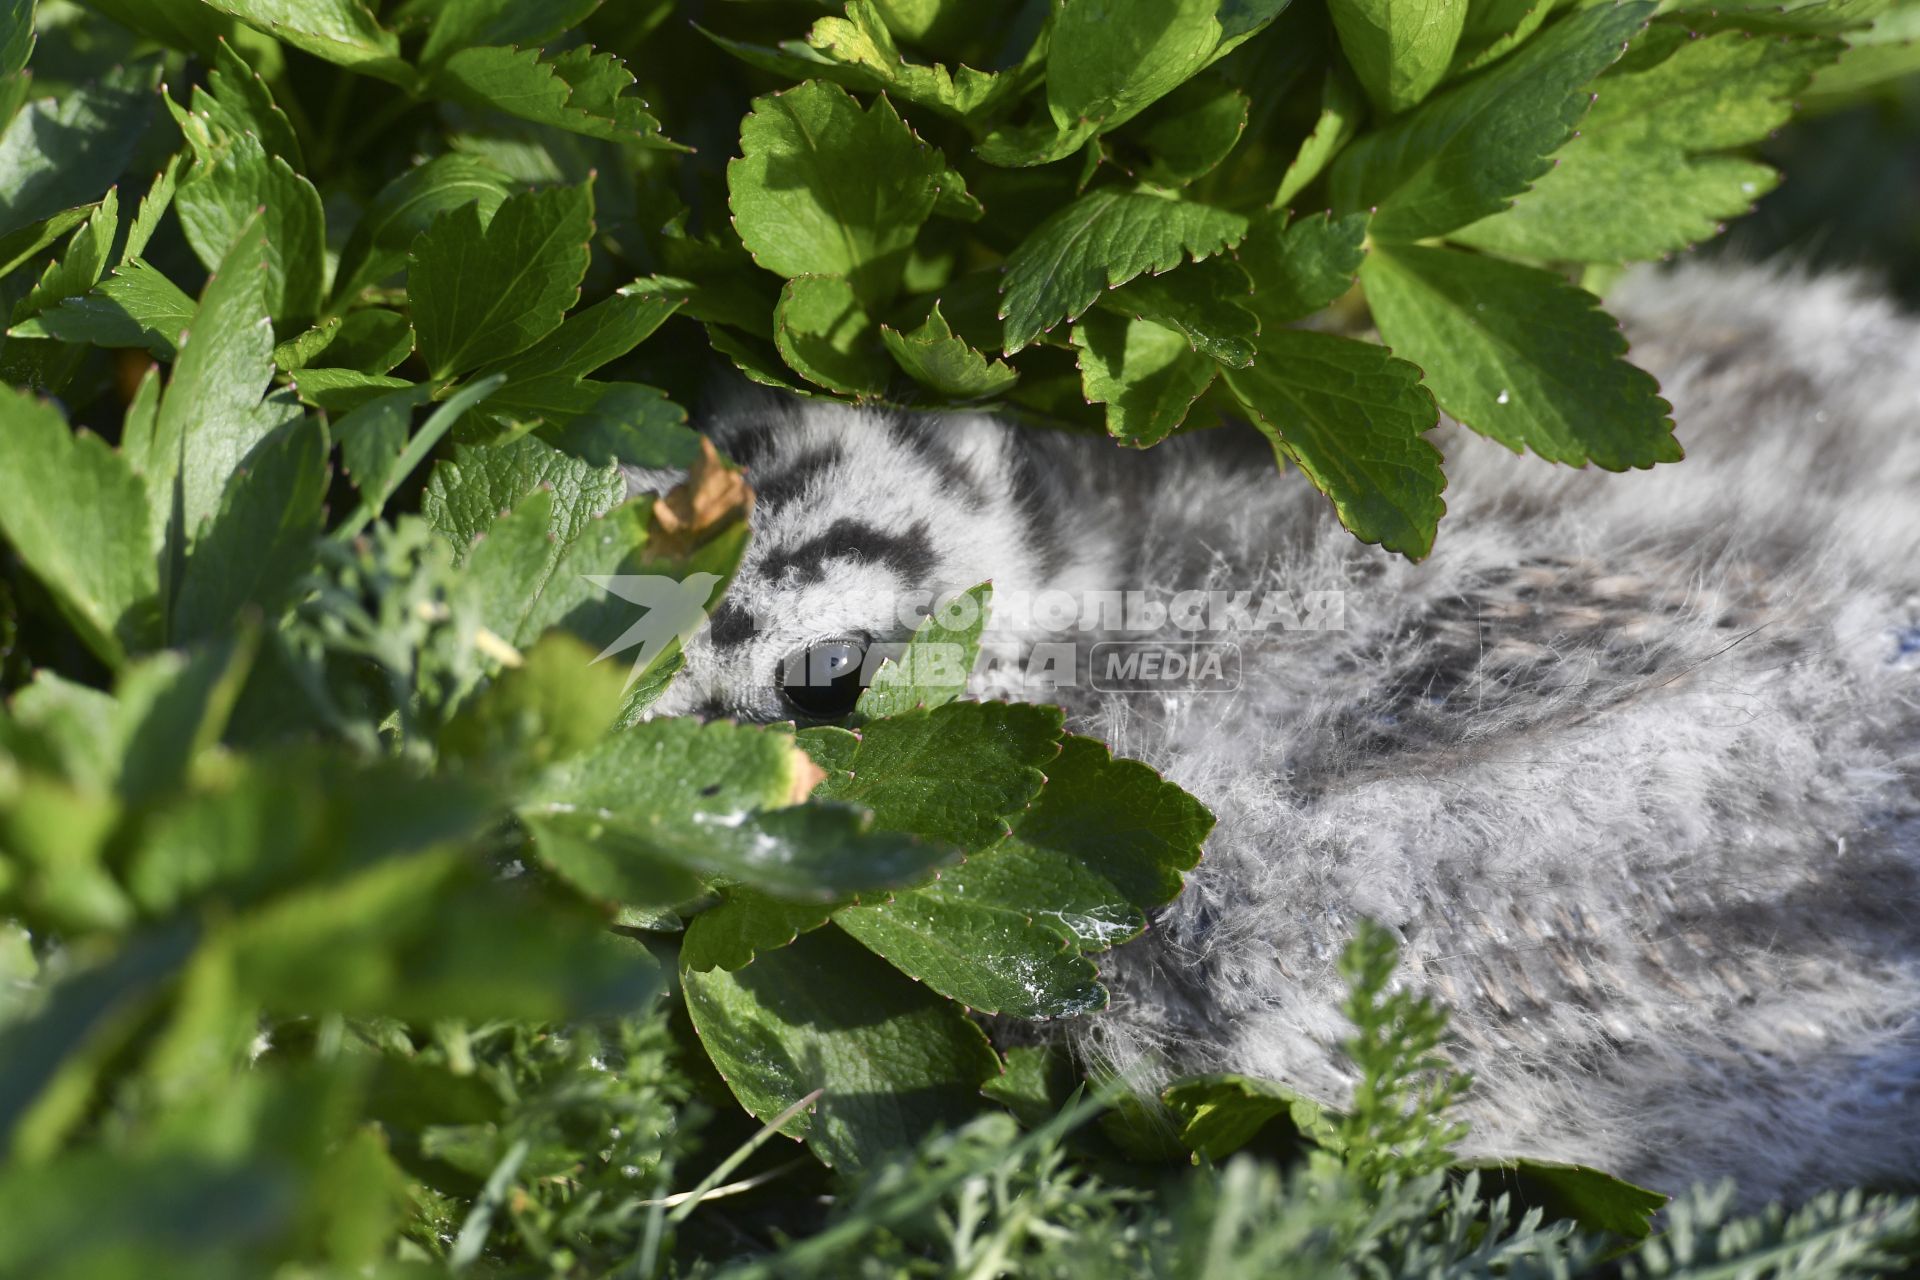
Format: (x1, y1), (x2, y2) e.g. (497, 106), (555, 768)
(0, 0), (1916, 1278)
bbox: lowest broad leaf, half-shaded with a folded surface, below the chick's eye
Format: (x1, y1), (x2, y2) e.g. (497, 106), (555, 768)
(682, 929), (1000, 1169)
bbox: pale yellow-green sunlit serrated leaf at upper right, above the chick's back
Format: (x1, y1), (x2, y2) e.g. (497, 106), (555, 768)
(1452, 31), (1841, 261)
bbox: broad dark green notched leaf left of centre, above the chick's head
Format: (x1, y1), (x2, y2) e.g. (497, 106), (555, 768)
(407, 184), (593, 380)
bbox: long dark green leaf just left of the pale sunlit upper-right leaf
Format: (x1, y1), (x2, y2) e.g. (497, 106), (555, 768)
(1332, 0), (1653, 242)
